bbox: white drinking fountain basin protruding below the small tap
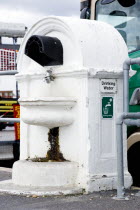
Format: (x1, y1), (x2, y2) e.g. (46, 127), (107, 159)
(19, 97), (76, 129)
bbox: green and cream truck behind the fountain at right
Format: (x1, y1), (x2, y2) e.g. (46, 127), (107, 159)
(80, 0), (140, 187)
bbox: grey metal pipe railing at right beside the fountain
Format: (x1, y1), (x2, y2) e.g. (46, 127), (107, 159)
(116, 58), (140, 199)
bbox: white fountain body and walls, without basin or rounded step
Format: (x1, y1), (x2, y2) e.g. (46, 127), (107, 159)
(17, 17), (131, 192)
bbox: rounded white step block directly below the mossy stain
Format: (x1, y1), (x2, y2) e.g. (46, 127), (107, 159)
(12, 160), (78, 188)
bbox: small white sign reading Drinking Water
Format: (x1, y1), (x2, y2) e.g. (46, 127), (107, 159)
(100, 79), (117, 93)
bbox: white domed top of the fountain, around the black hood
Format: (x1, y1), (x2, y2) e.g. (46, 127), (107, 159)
(18, 17), (128, 74)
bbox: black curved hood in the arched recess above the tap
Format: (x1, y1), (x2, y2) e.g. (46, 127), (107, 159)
(25, 35), (63, 66)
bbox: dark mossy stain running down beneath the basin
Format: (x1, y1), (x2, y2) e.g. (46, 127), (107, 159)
(46, 127), (65, 162)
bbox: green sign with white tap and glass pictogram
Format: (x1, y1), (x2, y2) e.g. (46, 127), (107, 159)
(102, 97), (113, 118)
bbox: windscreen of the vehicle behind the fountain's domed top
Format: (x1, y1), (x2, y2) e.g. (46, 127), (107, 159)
(95, 0), (140, 52)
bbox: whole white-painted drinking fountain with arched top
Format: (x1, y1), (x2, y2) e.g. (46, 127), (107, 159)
(13, 17), (131, 192)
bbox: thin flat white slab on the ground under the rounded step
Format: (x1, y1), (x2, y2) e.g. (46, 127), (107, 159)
(0, 180), (83, 196)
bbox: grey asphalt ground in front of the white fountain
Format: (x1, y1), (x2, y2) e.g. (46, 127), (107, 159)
(0, 167), (140, 210)
